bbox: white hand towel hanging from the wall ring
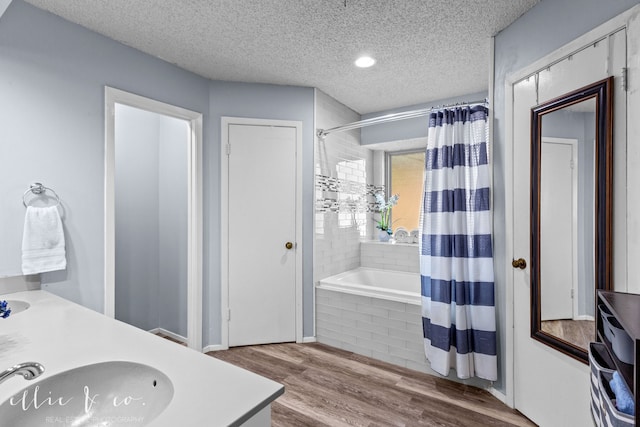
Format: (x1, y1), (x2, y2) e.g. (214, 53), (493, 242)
(22, 206), (67, 274)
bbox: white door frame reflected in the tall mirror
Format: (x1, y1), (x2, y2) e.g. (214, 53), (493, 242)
(541, 136), (580, 320)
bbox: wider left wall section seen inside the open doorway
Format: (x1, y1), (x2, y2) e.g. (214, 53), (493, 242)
(114, 104), (160, 330)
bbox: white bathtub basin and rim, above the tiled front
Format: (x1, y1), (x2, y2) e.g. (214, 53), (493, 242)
(316, 267), (421, 305)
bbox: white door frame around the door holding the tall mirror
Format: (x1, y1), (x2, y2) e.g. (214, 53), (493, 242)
(504, 6), (640, 408)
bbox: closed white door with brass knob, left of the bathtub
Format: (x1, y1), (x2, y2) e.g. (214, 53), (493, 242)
(228, 124), (297, 346)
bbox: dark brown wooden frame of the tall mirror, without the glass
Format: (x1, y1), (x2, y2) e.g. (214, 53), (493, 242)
(531, 77), (613, 364)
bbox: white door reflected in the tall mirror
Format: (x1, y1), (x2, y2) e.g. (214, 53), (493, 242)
(540, 138), (578, 321)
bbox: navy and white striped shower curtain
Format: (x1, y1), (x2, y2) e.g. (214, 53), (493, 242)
(419, 106), (497, 380)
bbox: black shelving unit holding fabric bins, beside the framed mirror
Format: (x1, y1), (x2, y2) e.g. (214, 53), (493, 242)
(596, 291), (640, 426)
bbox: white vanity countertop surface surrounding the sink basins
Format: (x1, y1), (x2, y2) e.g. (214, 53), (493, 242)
(0, 291), (284, 427)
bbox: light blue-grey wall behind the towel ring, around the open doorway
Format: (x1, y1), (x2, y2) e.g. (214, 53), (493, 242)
(0, 0), (213, 312)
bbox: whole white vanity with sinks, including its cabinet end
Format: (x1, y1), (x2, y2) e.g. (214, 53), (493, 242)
(0, 290), (284, 427)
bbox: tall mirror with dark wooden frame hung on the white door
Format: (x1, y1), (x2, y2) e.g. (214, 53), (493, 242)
(531, 77), (613, 363)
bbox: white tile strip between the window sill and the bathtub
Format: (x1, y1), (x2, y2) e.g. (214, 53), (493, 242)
(360, 241), (420, 273)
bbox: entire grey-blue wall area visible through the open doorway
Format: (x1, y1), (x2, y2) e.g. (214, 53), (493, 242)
(115, 104), (188, 337)
